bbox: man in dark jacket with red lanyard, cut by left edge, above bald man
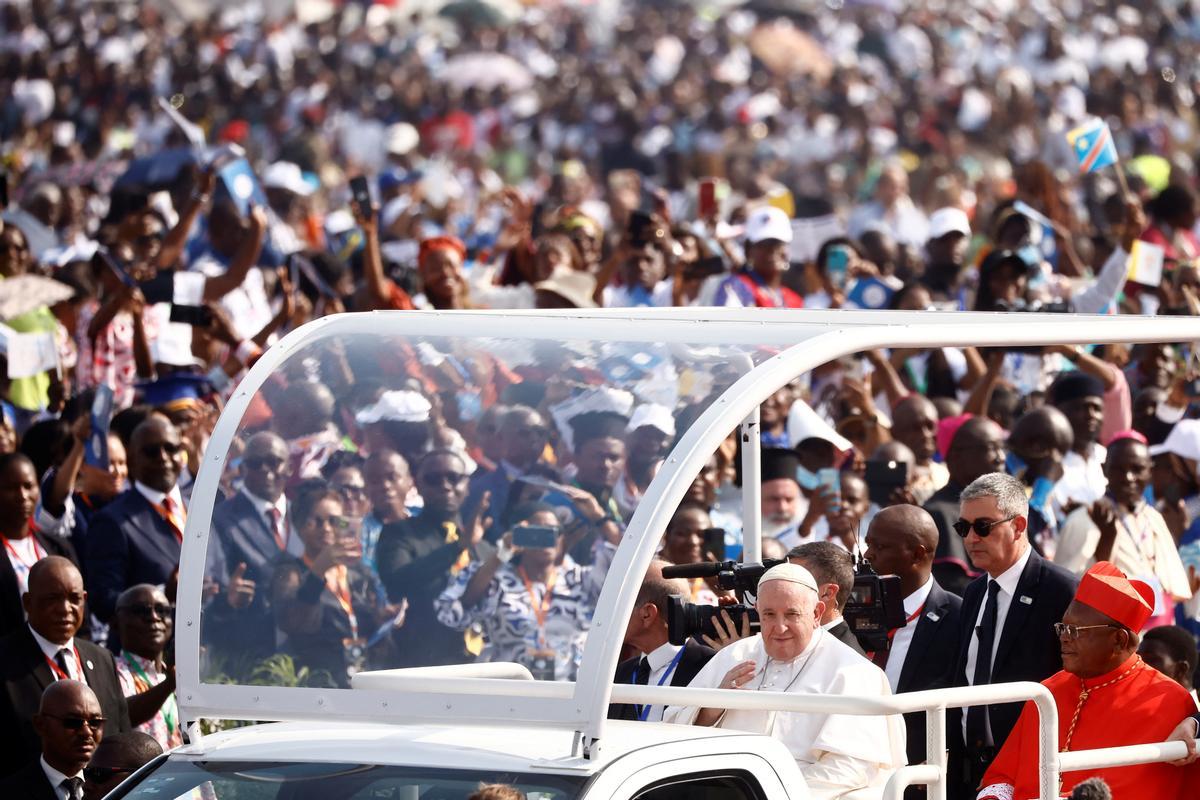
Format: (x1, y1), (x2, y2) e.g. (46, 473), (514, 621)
(0, 453), (79, 636)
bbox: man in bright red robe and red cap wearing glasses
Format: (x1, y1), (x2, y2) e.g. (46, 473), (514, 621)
(978, 561), (1196, 800)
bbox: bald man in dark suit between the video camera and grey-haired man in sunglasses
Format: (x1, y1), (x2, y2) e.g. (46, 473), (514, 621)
(865, 505), (962, 777)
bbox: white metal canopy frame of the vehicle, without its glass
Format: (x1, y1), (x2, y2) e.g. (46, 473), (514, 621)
(176, 308), (1200, 800)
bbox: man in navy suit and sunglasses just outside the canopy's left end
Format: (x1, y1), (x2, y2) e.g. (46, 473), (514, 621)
(88, 414), (187, 622)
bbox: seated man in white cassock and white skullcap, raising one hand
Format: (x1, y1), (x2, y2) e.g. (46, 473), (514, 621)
(662, 564), (905, 800)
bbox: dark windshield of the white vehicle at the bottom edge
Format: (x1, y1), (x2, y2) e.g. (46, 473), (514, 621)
(109, 759), (584, 800)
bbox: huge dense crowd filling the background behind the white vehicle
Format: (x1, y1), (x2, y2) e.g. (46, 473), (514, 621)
(0, 0), (1200, 800)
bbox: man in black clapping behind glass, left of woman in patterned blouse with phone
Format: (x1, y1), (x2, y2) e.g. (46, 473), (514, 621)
(376, 450), (487, 667)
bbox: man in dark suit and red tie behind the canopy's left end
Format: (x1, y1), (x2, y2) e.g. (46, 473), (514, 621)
(203, 433), (294, 674)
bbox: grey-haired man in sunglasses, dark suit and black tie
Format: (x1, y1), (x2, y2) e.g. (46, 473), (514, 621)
(949, 473), (1079, 798)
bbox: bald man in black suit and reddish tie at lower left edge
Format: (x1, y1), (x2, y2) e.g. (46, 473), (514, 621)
(0, 555), (130, 775)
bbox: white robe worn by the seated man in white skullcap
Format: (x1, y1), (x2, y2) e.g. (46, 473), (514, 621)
(662, 628), (906, 800)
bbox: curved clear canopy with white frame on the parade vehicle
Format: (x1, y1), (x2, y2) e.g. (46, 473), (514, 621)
(176, 308), (1200, 738)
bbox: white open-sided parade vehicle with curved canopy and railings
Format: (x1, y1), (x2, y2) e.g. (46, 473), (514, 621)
(98, 308), (1200, 800)
